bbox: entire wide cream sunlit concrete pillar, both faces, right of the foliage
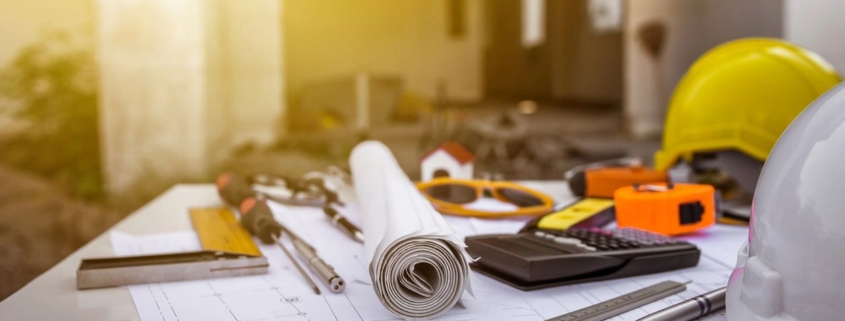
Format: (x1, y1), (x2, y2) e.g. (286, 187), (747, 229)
(97, 0), (283, 194)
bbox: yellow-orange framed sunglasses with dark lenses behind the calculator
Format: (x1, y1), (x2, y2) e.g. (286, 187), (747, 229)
(417, 178), (554, 218)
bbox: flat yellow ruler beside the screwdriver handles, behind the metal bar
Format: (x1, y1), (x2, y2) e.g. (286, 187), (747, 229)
(190, 207), (262, 256)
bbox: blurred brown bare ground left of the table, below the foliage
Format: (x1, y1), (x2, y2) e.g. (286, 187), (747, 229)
(0, 166), (119, 300)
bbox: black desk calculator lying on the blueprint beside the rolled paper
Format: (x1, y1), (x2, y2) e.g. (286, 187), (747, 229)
(466, 228), (701, 291)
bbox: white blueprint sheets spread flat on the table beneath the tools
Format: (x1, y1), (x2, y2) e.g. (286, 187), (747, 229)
(111, 204), (747, 321)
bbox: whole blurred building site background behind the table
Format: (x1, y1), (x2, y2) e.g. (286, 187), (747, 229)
(0, 0), (845, 299)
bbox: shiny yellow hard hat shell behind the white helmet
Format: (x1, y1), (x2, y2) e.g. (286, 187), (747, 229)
(654, 38), (841, 170)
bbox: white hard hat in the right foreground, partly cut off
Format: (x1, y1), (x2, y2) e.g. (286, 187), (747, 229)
(726, 84), (845, 321)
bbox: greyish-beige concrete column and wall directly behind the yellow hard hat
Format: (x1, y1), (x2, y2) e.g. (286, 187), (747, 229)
(623, 0), (784, 137)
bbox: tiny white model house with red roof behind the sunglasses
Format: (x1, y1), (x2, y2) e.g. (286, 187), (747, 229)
(420, 142), (475, 182)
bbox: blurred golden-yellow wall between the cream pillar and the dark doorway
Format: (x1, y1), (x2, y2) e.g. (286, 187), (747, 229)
(285, 0), (483, 100)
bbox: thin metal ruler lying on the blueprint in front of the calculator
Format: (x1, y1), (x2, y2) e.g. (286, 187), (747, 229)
(546, 281), (689, 321)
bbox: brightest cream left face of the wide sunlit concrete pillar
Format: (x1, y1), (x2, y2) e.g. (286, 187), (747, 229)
(97, 0), (208, 193)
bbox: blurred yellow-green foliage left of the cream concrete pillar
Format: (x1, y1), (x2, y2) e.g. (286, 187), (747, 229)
(0, 33), (103, 199)
